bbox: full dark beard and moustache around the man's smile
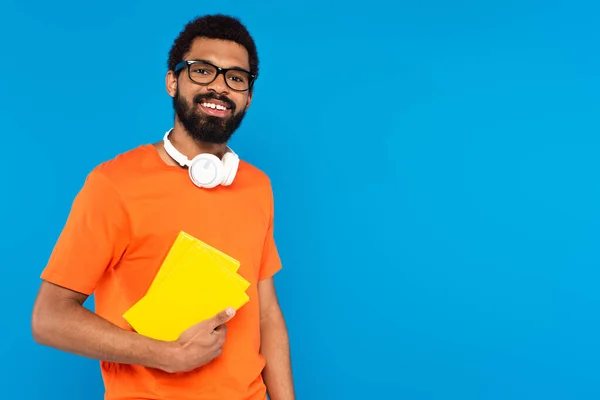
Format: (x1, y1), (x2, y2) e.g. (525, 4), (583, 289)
(173, 90), (246, 144)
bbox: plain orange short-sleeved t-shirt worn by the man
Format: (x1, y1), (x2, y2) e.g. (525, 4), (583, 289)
(41, 144), (281, 400)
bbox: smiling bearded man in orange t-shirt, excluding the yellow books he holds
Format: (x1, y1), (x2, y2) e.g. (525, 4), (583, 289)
(32, 15), (294, 400)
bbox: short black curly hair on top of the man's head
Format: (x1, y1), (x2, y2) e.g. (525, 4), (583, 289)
(167, 14), (258, 76)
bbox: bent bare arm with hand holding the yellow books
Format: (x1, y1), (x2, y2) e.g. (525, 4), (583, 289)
(31, 281), (231, 372)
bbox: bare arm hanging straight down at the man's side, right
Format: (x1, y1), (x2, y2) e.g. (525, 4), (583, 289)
(258, 278), (295, 400)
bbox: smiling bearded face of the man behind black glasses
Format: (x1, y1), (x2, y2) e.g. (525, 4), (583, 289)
(167, 38), (252, 144)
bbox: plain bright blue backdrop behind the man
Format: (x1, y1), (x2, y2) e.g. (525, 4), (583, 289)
(0, 0), (600, 400)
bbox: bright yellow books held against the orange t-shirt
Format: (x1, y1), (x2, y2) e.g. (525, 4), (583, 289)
(123, 232), (250, 341)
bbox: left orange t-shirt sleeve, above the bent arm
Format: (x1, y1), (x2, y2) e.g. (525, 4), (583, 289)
(41, 169), (130, 295)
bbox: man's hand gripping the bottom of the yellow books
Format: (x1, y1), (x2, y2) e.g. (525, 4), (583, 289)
(167, 308), (235, 372)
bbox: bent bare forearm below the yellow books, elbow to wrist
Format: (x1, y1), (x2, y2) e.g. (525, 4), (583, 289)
(32, 301), (170, 369)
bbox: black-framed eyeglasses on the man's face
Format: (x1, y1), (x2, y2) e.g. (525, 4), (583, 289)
(174, 60), (256, 92)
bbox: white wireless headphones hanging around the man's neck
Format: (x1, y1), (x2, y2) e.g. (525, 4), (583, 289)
(163, 129), (240, 189)
